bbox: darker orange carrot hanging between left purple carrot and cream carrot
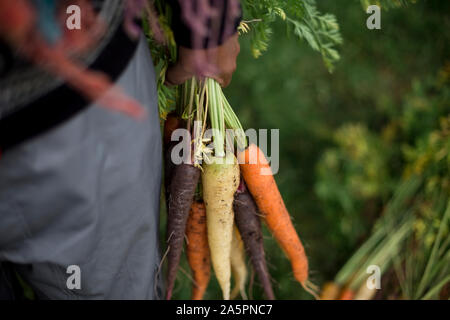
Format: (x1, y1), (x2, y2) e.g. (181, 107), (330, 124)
(186, 202), (211, 300)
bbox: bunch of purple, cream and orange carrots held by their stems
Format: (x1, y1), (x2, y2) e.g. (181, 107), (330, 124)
(164, 78), (316, 300)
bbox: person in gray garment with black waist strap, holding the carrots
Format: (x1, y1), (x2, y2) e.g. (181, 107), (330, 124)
(0, 0), (240, 299)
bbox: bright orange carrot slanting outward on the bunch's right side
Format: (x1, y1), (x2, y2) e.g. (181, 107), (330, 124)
(238, 144), (317, 297)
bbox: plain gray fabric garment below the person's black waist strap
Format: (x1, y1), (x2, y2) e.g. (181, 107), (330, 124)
(0, 37), (162, 299)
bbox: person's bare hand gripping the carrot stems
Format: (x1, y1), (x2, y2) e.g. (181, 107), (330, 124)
(166, 33), (240, 87)
